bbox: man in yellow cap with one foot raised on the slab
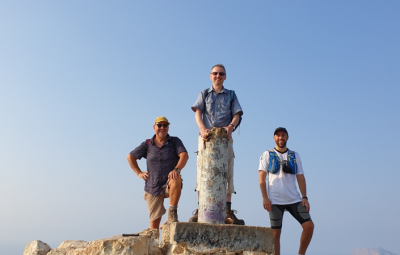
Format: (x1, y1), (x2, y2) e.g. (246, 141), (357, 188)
(127, 117), (189, 239)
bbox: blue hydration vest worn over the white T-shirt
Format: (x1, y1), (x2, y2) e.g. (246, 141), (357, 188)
(268, 149), (297, 174)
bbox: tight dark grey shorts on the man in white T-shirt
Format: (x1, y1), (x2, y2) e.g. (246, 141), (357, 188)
(269, 202), (311, 229)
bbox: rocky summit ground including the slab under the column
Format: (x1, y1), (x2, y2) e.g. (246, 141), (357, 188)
(23, 222), (274, 255)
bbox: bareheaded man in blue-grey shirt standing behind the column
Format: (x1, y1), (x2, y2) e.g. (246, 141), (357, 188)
(189, 64), (244, 225)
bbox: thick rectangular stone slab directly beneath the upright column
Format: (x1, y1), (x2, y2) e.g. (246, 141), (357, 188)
(161, 222), (275, 255)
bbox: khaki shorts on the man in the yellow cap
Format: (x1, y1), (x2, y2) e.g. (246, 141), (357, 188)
(143, 178), (183, 222)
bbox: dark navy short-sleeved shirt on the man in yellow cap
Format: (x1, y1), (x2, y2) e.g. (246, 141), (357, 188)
(131, 135), (187, 196)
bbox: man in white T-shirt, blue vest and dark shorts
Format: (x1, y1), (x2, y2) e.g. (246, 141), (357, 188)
(258, 127), (314, 255)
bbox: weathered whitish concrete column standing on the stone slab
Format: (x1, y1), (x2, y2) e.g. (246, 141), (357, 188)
(198, 127), (228, 224)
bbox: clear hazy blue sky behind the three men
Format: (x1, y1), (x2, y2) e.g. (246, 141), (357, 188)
(0, 0), (400, 255)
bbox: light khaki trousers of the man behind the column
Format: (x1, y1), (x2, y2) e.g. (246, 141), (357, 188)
(195, 135), (236, 194)
